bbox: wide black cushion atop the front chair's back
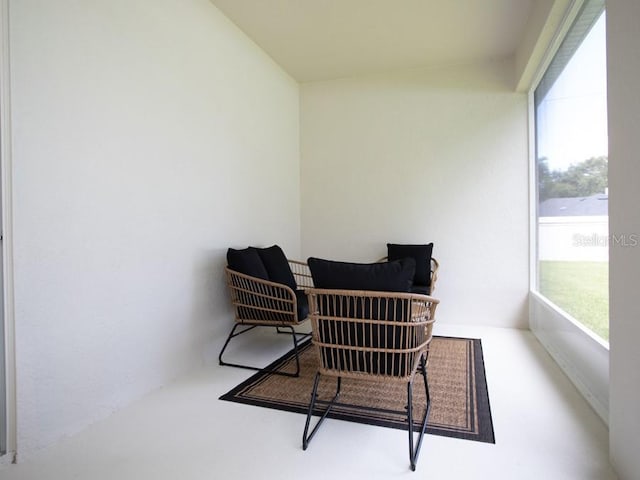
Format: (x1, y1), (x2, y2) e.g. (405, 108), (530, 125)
(307, 257), (416, 292)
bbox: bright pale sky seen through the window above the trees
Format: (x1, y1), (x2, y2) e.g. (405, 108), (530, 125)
(537, 13), (608, 174)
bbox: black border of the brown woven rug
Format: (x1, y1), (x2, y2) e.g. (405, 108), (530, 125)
(218, 335), (495, 444)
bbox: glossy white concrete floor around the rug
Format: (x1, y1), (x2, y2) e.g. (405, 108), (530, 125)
(0, 324), (617, 480)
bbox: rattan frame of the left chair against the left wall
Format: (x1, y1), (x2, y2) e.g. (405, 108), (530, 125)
(218, 260), (313, 376)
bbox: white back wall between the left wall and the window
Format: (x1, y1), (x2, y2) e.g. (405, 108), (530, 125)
(301, 61), (528, 328)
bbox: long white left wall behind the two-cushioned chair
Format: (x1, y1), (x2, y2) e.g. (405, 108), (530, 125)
(10, 0), (300, 458)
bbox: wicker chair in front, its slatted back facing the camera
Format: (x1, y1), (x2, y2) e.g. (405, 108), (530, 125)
(302, 288), (439, 470)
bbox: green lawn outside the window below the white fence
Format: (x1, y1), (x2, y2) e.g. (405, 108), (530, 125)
(540, 261), (609, 341)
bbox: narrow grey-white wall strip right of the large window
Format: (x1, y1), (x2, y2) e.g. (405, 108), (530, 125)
(607, 0), (640, 480)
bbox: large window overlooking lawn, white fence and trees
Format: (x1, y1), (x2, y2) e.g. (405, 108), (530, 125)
(534, 0), (608, 341)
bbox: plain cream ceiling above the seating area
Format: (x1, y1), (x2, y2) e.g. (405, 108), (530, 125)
(211, 0), (540, 82)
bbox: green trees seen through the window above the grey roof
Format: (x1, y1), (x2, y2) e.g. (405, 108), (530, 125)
(538, 157), (609, 202)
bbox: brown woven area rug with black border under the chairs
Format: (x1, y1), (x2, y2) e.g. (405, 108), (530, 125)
(220, 336), (495, 443)
